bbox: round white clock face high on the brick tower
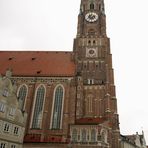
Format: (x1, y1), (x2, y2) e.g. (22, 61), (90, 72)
(85, 12), (98, 23)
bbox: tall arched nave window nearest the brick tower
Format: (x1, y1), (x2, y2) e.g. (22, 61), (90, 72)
(51, 85), (64, 129)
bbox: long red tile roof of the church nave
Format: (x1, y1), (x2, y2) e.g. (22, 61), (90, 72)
(0, 51), (75, 76)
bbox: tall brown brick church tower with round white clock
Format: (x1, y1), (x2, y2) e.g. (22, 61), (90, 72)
(71, 0), (120, 148)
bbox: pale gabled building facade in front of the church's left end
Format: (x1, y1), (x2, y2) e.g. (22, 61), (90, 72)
(0, 70), (27, 148)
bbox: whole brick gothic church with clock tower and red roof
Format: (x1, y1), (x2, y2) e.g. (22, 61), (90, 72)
(0, 0), (120, 148)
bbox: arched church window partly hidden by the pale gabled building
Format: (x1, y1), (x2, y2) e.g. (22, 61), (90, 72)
(17, 85), (27, 110)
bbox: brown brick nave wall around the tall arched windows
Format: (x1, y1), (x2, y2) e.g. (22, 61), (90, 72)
(12, 77), (76, 141)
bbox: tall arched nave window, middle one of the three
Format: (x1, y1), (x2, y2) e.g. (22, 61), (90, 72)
(32, 85), (45, 129)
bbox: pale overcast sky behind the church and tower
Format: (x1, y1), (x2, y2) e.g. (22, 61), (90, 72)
(0, 0), (148, 143)
